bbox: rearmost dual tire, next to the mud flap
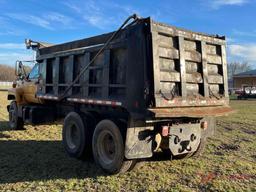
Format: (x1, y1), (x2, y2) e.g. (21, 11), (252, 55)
(92, 120), (136, 174)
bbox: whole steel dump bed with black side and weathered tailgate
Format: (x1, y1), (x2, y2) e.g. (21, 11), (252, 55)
(37, 18), (231, 118)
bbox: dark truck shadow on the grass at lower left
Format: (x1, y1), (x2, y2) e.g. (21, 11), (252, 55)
(0, 139), (105, 184)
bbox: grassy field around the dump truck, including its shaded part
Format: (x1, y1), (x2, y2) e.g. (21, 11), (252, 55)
(0, 92), (256, 191)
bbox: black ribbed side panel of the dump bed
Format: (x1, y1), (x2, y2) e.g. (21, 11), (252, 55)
(37, 22), (151, 118)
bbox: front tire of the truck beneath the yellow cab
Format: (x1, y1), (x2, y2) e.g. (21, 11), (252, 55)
(9, 101), (24, 130)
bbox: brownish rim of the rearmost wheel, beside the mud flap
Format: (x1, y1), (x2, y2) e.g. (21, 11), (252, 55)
(98, 131), (116, 164)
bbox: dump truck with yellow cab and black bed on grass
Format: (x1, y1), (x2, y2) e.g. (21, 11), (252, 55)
(8, 15), (232, 174)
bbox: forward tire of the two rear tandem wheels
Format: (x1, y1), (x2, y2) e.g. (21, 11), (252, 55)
(62, 112), (91, 159)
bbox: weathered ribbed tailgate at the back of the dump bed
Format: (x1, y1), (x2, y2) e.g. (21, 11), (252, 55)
(150, 20), (228, 107)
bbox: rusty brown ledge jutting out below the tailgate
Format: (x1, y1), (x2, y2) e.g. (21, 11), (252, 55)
(149, 106), (235, 118)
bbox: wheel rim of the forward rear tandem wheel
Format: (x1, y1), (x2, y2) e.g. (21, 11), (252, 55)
(66, 124), (80, 149)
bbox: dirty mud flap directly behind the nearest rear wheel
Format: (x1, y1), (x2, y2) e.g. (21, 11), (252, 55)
(125, 121), (154, 159)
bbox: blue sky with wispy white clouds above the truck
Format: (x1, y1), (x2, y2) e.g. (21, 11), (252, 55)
(0, 0), (256, 68)
